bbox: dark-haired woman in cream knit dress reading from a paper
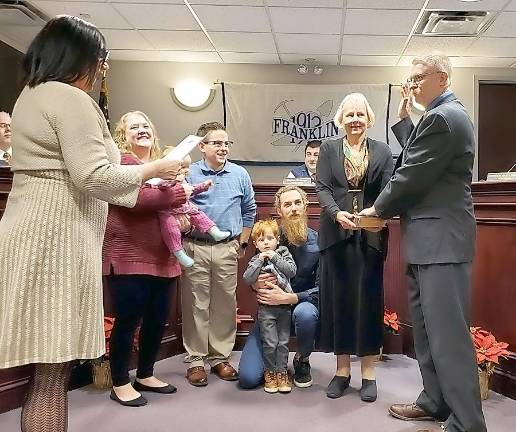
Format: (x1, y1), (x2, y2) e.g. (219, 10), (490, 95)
(0, 15), (180, 432)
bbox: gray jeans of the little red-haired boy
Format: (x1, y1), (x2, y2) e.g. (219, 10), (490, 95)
(258, 305), (290, 372)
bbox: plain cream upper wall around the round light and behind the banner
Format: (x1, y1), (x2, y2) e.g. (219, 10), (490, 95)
(108, 61), (516, 183)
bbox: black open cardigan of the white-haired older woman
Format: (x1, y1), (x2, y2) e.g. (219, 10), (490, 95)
(316, 138), (393, 252)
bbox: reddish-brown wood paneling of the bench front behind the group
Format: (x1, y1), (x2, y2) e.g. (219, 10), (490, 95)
(0, 167), (516, 412)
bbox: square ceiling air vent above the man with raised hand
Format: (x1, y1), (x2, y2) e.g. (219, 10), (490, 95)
(416, 10), (494, 36)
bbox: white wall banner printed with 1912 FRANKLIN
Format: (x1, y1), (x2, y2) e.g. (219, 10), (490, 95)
(224, 83), (399, 163)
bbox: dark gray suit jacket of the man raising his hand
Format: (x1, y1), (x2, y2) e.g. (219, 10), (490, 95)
(374, 93), (476, 264)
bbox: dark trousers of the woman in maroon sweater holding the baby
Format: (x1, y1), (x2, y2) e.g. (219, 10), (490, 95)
(108, 275), (177, 387)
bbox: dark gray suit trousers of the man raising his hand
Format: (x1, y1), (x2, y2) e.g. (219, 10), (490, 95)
(407, 263), (487, 432)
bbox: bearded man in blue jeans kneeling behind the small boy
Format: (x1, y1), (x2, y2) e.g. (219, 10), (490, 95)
(238, 185), (319, 389)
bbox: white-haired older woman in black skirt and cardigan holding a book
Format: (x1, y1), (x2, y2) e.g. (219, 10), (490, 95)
(317, 93), (393, 402)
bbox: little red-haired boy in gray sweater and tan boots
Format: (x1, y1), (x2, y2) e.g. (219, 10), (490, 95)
(243, 219), (297, 393)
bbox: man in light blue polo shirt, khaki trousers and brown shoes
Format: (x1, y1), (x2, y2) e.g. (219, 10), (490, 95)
(181, 122), (256, 386)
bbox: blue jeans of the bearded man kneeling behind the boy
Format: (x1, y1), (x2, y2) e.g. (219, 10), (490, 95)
(238, 301), (319, 389)
